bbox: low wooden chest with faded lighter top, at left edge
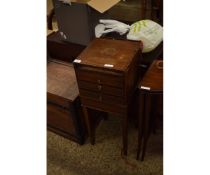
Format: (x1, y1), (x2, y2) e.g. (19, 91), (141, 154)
(47, 60), (85, 144)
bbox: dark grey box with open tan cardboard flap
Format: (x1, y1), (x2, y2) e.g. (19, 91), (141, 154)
(53, 0), (120, 45)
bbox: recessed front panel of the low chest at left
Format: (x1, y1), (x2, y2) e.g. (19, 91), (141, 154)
(47, 104), (76, 135)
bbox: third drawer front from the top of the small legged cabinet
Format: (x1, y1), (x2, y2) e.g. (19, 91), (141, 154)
(80, 89), (125, 105)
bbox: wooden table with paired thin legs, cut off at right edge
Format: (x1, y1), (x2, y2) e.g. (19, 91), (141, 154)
(137, 60), (163, 161)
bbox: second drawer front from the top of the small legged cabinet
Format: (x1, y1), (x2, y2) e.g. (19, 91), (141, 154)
(78, 81), (124, 97)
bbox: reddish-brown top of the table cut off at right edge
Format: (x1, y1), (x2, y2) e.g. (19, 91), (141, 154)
(138, 60), (163, 93)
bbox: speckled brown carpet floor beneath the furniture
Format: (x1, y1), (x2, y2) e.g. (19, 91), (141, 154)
(47, 118), (163, 175)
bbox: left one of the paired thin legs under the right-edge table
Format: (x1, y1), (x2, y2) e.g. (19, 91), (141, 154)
(136, 92), (145, 160)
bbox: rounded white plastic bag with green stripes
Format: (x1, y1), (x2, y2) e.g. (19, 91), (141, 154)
(127, 20), (163, 53)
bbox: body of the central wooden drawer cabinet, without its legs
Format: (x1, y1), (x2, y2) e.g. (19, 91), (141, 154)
(74, 39), (140, 114)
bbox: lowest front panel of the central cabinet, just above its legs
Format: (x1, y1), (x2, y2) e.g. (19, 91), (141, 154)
(81, 97), (126, 114)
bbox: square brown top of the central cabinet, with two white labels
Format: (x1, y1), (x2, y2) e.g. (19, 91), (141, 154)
(74, 38), (141, 71)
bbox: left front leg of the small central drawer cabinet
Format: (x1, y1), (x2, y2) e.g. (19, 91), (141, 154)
(82, 106), (95, 145)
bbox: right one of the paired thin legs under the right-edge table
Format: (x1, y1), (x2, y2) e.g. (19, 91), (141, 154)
(141, 94), (151, 161)
